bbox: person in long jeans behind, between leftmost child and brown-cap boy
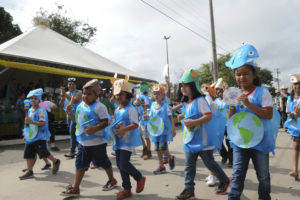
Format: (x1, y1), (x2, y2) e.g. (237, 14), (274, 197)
(59, 77), (82, 158)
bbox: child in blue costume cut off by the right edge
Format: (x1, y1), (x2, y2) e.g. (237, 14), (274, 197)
(284, 74), (300, 180)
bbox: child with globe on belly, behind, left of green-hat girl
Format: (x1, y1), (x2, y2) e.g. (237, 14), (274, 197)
(148, 85), (176, 174)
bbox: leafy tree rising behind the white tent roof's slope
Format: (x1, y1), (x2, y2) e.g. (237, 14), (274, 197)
(36, 4), (97, 45)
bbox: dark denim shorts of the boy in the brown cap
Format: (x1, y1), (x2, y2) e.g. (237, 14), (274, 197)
(75, 143), (111, 171)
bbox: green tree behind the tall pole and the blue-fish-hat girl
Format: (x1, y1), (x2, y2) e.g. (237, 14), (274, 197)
(199, 54), (273, 86)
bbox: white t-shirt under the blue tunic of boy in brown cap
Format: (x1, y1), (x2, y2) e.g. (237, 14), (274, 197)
(79, 102), (108, 146)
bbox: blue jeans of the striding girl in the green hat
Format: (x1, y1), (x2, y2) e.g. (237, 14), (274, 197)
(184, 150), (229, 191)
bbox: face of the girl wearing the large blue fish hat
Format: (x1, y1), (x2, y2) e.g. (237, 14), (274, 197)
(234, 66), (256, 88)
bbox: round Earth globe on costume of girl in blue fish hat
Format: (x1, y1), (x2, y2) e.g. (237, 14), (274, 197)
(227, 112), (264, 148)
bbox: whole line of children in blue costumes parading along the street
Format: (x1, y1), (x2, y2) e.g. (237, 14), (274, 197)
(19, 44), (300, 200)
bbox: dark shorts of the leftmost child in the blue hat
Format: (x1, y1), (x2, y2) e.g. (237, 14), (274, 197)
(24, 140), (50, 159)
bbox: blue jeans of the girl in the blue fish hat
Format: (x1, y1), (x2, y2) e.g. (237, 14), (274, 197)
(228, 147), (271, 200)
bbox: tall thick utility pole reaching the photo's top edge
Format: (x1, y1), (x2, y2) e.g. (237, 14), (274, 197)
(209, 0), (218, 82)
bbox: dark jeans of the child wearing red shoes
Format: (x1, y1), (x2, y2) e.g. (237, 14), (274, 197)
(116, 149), (142, 190)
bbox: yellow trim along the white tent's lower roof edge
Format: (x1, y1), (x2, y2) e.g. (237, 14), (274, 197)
(0, 59), (152, 83)
